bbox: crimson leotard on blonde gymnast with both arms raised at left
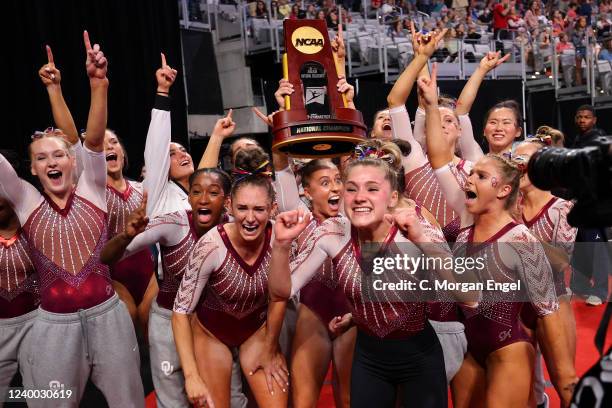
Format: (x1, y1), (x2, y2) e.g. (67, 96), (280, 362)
(0, 147), (115, 313)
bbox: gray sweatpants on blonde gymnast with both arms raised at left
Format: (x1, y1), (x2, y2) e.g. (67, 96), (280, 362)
(24, 294), (144, 408)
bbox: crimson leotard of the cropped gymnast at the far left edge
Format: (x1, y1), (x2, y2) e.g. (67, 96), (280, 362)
(0, 230), (40, 319)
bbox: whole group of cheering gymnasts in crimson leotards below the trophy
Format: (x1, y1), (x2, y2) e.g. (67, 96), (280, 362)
(0, 25), (576, 408)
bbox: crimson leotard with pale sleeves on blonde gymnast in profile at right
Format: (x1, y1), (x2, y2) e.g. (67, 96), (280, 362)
(435, 163), (559, 365)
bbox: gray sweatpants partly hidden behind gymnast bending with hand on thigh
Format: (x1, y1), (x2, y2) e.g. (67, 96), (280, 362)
(149, 300), (248, 408)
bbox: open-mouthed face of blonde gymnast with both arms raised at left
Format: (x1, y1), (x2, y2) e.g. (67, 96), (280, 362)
(30, 136), (76, 196)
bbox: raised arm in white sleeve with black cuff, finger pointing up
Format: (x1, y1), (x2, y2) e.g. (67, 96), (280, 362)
(143, 54), (176, 216)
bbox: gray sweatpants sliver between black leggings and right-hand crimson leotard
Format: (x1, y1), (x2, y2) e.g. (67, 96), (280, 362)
(429, 320), (467, 384)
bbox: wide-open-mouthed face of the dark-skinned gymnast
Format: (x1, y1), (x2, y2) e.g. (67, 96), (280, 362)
(189, 173), (226, 236)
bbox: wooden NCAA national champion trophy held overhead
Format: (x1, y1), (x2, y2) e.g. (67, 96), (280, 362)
(272, 19), (366, 158)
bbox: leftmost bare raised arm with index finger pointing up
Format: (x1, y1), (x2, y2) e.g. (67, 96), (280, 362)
(38, 45), (80, 145)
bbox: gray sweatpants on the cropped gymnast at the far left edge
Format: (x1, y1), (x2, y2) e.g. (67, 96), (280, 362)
(0, 310), (38, 407)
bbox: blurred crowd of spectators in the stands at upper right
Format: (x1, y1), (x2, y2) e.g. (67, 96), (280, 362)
(248, 0), (612, 86)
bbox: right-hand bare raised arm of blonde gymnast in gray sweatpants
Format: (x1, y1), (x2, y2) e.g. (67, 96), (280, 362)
(83, 31), (108, 152)
